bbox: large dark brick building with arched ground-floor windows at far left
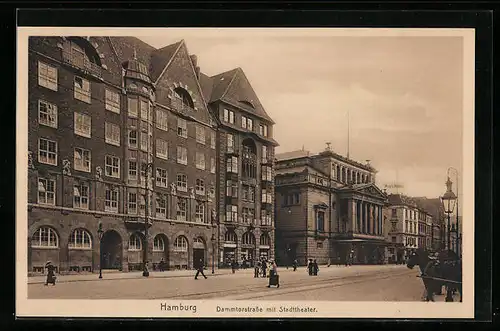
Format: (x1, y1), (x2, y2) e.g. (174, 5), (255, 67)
(27, 37), (273, 273)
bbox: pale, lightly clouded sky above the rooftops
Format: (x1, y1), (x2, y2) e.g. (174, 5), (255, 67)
(139, 29), (463, 198)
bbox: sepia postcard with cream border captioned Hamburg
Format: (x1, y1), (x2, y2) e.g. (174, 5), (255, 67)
(16, 27), (475, 318)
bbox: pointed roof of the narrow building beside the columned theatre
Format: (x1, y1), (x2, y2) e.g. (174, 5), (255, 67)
(216, 68), (274, 124)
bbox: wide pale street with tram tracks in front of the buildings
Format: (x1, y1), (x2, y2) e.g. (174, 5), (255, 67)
(28, 265), (458, 301)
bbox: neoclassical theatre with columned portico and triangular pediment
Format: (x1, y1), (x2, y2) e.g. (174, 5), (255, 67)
(275, 146), (387, 265)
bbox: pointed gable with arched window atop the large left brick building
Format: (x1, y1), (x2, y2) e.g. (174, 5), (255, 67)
(156, 40), (211, 123)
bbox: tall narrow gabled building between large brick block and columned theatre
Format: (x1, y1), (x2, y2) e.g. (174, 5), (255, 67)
(201, 68), (277, 267)
